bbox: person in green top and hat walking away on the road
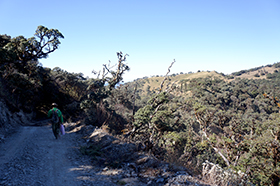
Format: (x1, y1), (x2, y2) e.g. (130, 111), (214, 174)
(48, 103), (63, 139)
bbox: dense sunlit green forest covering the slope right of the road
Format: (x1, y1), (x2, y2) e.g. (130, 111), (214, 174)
(126, 64), (280, 185)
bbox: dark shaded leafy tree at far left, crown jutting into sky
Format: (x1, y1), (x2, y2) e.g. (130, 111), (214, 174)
(0, 26), (63, 112)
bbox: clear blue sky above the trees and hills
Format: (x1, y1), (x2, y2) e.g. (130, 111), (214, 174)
(0, 0), (280, 81)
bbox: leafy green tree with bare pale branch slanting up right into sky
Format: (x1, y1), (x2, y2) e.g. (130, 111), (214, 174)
(130, 60), (176, 150)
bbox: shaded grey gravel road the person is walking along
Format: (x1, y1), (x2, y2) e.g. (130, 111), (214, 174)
(0, 125), (115, 186)
